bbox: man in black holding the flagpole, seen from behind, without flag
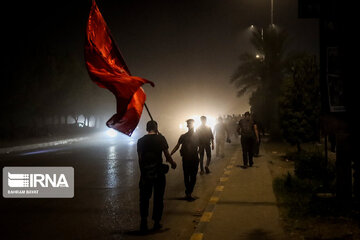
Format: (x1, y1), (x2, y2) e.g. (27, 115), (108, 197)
(137, 121), (176, 232)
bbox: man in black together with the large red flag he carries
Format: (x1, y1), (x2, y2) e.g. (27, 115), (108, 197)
(85, 1), (176, 232)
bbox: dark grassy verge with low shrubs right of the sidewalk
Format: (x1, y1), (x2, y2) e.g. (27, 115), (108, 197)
(264, 142), (360, 240)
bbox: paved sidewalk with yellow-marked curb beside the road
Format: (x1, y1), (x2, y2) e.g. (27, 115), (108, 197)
(191, 145), (285, 240)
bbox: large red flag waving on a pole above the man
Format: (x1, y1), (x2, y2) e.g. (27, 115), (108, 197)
(85, 0), (154, 136)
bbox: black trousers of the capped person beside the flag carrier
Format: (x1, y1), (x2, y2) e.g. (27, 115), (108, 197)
(183, 157), (199, 194)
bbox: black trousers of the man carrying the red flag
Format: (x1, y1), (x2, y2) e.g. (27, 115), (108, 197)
(139, 174), (166, 222)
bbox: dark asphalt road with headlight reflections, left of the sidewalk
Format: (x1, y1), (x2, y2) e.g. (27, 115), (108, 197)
(0, 134), (237, 240)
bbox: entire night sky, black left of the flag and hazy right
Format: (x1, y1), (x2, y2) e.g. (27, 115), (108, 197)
(2, 0), (319, 123)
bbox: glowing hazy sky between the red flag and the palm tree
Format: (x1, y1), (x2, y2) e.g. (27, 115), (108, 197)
(98, 0), (318, 124)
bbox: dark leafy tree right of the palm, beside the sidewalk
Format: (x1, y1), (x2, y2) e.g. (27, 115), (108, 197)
(279, 54), (320, 151)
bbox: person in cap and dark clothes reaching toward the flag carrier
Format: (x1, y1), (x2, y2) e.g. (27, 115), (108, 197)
(171, 119), (199, 201)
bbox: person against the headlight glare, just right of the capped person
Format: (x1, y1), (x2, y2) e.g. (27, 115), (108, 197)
(196, 116), (214, 175)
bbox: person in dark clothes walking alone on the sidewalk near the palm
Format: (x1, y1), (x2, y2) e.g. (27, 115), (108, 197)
(238, 112), (259, 167)
